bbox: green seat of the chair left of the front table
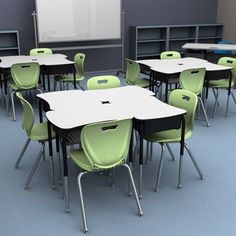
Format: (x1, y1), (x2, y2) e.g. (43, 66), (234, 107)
(29, 122), (55, 141)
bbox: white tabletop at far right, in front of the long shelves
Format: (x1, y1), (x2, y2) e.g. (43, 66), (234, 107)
(182, 43), (236, 51)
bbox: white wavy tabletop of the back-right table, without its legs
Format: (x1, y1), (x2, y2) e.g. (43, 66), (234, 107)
(137, 57), (231, 74)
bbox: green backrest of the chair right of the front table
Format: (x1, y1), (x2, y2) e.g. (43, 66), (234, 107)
(169, 89), (198, 135)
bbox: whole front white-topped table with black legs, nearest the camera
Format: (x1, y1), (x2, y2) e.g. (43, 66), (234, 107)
(37, 86), (186, 211)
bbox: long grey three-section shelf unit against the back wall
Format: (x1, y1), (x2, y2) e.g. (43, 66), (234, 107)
(130, 24), (223, 60)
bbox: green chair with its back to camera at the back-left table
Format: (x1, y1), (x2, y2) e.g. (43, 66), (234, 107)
(10, 62), (42, 121)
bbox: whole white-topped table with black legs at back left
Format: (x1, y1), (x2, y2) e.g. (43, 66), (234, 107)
(0, 54), (76, 111)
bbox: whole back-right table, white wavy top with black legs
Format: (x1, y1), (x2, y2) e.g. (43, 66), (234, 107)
(137, 57), (232, 101)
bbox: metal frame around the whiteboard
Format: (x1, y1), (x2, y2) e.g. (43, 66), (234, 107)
(35, 0), (124, 43)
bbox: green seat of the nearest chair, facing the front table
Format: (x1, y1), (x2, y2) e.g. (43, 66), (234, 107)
(70, 149), (93, 171)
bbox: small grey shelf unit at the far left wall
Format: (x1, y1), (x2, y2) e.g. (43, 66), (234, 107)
(0, 30), (20, 56)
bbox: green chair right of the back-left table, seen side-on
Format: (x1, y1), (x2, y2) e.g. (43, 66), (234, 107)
(54, 53), (85, 90)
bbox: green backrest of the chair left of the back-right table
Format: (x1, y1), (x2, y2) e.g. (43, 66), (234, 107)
(125, 58), (140, 85)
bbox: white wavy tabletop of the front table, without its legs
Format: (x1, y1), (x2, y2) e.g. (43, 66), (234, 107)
(37, 86), (186, 129)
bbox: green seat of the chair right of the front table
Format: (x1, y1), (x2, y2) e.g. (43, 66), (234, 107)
(144, 129), (192, 143)
